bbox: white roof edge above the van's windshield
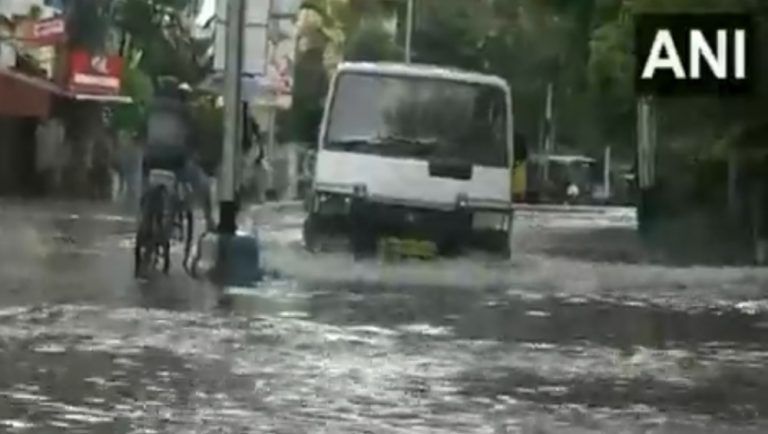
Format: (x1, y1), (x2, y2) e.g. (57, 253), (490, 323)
(338, 62), (509, 90)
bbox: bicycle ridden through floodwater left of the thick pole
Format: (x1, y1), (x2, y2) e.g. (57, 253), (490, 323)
(134, 169), (194, 277)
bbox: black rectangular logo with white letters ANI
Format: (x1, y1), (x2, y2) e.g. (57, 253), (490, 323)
(635, 14), (758, 96)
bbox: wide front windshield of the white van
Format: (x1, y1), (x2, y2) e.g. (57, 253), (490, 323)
(325, 72), (507, 167)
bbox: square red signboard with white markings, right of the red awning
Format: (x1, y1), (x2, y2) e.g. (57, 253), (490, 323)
(69, 50), (123, 95)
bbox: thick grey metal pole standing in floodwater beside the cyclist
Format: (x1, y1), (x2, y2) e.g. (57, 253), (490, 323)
(219, 0), (244, 234)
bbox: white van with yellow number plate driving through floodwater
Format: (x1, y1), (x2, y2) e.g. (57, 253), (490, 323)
(304, 63), (514, 257)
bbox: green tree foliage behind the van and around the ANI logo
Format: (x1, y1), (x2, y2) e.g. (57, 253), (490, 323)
(284, 0), (768, 159)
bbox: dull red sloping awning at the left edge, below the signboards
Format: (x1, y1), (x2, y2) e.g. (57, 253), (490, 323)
(0, 68), (61, 117)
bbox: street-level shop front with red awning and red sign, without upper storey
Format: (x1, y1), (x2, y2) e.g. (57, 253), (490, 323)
(0, 51), (131, 198)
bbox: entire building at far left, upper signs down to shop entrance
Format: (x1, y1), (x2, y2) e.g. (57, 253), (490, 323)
(0, 0), (130, 197)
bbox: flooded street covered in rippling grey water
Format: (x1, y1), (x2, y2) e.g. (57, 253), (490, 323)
(0, 203), (768, 434)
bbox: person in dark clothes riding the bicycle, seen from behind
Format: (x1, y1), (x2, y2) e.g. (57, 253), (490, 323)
(143, 84), (214, 230)
